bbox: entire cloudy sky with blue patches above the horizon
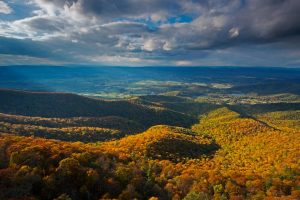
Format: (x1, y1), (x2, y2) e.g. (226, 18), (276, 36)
(0, 0), (300, 67)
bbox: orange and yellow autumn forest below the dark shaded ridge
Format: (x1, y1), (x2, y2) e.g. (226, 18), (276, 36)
(0, 100), (300, 200)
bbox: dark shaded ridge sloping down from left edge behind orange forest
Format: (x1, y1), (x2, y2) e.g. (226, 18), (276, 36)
(0, 89), (196, 127)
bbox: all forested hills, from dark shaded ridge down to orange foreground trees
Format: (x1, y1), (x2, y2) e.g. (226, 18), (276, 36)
(0, 90), (300, 200)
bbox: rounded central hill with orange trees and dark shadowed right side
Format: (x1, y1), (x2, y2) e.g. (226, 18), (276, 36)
(102, 125), (218, 162)
